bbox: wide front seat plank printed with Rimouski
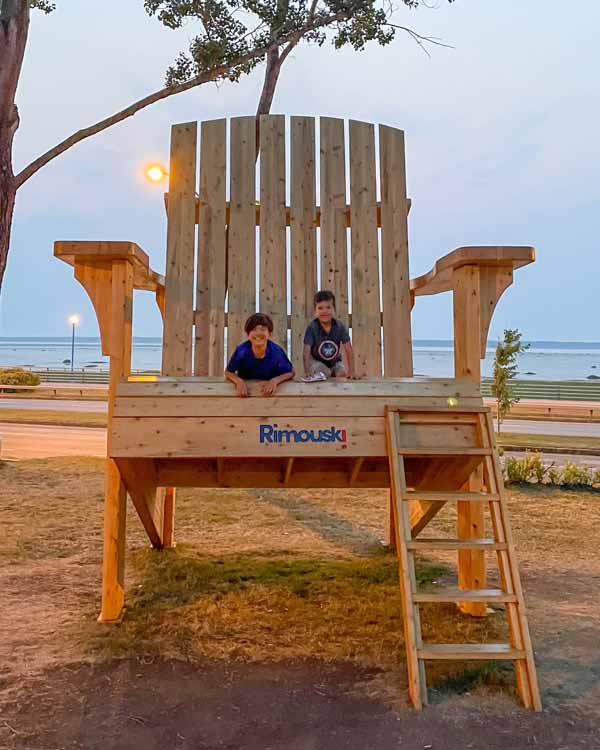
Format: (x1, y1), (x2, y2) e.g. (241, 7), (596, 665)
(111, 417), (386, 458)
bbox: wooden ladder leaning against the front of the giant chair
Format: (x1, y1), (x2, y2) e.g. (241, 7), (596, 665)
(386, 407), (541, 711)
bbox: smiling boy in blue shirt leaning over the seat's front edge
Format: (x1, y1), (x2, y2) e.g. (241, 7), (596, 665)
(225, 313), (294, 398)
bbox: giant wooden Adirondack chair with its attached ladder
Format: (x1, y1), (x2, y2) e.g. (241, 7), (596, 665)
(55, 116), (540, 708)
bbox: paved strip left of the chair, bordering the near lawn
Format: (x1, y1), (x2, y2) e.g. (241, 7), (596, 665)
(0, 422), (106, 458)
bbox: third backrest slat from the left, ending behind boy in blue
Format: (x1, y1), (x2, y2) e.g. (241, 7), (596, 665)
(227, 117), (256, 356)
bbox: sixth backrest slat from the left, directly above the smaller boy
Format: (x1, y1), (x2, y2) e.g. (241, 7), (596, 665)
(320, 117), (348, 323)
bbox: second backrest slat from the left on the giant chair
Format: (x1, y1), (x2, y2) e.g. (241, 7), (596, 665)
(194, 120), (227, 375)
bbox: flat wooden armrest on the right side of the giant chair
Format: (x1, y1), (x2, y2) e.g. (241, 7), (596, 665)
(410, 246), (535, 297)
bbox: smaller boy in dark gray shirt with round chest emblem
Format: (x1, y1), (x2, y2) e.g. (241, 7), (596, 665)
(303, 290), (357, 380)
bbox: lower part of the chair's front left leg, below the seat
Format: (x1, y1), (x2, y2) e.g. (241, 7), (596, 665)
(98, 458), (127, 622)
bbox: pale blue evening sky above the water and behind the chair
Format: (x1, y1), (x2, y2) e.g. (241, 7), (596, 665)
(0, 0), (600, 341)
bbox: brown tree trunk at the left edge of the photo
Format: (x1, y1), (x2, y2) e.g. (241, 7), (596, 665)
(0, 0), (29, 291)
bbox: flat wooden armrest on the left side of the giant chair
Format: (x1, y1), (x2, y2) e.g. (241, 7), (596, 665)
(54, 241), (165, 292)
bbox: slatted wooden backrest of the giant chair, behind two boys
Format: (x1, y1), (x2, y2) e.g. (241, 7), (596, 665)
(163, 115), (412, 377)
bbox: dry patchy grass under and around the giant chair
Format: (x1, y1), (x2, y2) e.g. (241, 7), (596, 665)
(0, 459), (600, 704)
